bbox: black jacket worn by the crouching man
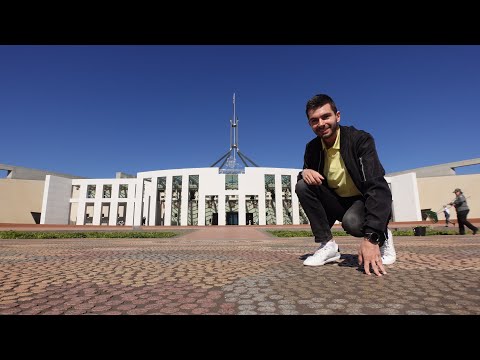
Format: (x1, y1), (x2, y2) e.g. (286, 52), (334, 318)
(297, 126), (392, 233)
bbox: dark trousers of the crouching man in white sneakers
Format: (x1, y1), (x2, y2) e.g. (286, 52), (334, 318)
(295, 179), (376, 242)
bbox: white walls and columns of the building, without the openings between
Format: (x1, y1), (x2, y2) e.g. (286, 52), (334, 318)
(41, 167), (421, 226)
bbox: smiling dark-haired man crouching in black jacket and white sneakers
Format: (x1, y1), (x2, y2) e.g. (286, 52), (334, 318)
(295, 94), (396, 276)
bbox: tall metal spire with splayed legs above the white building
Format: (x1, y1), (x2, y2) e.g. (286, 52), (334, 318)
(210, 93), (258, 174)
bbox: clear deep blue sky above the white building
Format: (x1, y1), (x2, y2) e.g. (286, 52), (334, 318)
(0, 45), (480, 178)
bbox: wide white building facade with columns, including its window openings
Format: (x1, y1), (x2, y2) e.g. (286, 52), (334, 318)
(40, 167), (421, 226)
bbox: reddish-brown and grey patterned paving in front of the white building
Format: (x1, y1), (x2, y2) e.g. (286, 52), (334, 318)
(0, 227), (480, 315)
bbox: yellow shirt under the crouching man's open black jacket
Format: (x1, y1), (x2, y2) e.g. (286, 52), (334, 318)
(321, 128), (362, 197)
